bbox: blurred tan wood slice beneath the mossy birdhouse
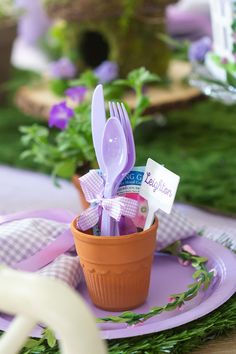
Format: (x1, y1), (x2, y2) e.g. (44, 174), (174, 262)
(15, 60), (202, 120)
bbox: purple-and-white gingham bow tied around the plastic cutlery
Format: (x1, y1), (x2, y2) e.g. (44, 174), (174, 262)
(77, 170), (138, 231)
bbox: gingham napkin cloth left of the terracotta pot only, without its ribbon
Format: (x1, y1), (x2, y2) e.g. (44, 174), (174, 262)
(0, 218), (82, 287)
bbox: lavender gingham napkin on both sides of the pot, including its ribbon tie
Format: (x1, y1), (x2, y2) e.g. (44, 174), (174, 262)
(0, 208), (195, 288)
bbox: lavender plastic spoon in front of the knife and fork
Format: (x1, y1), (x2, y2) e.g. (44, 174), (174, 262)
(101, 117), (128, 236)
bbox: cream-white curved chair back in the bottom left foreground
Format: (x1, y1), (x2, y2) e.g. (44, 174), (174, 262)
(0, 267), (107, 354)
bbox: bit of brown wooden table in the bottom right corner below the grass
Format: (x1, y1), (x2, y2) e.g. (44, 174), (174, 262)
(192, 331), (236, 354)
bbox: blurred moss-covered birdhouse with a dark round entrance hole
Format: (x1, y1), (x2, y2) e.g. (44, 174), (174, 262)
(44, 0), (169, 77)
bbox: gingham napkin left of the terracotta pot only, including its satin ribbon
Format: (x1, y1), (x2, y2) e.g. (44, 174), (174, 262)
(0, 217), (82, 287)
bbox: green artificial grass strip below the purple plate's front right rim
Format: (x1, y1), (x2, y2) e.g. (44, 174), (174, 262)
(109, 296), (236, 354)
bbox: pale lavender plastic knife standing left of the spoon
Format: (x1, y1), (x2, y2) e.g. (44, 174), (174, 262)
(91, 85), (106, 173)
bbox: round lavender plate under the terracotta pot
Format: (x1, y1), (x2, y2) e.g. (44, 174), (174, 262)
(0, 236), (236, 339)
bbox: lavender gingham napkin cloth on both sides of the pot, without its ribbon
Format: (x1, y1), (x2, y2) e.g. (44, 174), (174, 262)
(0, 208), (195, 287)
